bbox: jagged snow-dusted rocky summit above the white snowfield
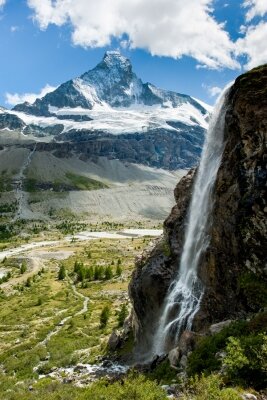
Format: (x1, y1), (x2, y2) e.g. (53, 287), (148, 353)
(14, 51), (207, 116)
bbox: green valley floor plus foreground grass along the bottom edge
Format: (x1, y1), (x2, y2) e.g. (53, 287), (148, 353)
(0, 228), (266, 400)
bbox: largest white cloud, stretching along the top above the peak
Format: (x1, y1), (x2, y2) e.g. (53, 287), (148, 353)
(28, 0), (239, 69)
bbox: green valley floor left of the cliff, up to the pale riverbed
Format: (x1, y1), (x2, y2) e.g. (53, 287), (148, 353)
(0, 229), (161, 399)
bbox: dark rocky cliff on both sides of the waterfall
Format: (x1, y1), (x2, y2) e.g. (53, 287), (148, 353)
(129, 65), (267, 349)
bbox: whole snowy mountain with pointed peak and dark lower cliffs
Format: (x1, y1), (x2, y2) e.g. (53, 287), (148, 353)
(0, 51), (210, 170)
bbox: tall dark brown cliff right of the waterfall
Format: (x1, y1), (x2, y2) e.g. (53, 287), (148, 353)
(195, 65), (267, 329)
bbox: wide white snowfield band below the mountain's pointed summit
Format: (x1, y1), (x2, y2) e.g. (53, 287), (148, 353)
(11, 100), (208, 135)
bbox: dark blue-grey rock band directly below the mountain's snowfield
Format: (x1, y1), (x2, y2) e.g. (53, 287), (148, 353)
(16, 124), (204, 170)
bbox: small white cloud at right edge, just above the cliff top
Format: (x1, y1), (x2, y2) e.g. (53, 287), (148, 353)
(236, 21), (267, 69)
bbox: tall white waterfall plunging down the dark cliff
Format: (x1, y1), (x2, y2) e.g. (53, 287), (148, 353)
(150, 87), (231, 356)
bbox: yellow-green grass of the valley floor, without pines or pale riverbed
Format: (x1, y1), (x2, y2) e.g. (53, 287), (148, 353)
(0, 238), (152, 382)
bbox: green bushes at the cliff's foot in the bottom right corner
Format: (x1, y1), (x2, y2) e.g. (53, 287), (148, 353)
(187, 311), (267, 388)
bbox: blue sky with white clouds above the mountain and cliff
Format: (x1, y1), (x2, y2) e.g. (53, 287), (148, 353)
(0, 0), (267, 107)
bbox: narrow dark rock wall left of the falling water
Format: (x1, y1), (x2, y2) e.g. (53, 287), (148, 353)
(129, 170), (194, 353)
